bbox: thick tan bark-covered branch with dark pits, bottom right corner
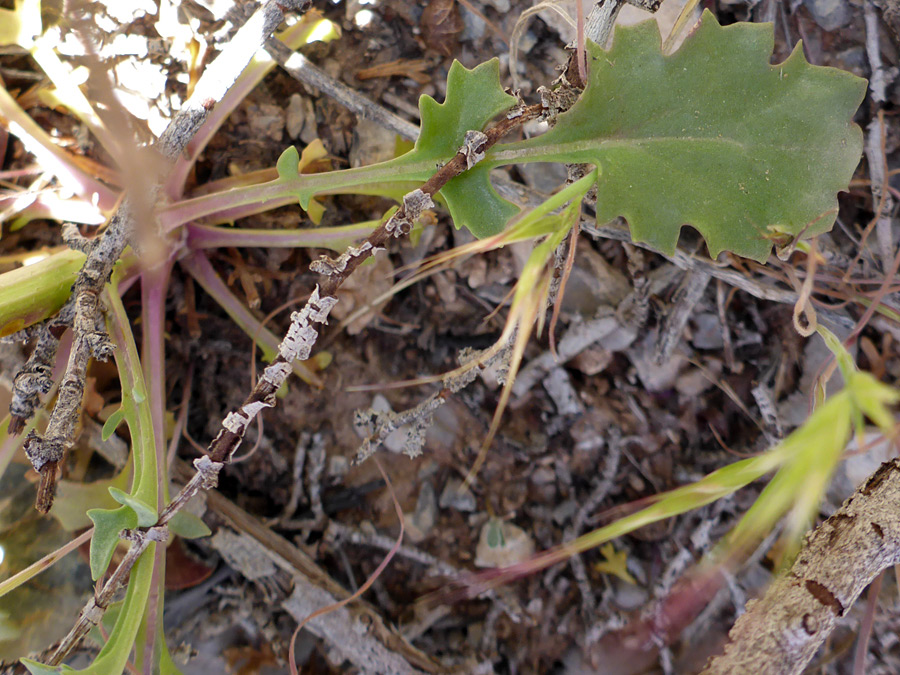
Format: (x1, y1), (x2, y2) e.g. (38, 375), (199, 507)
(703, 459), (900, 675)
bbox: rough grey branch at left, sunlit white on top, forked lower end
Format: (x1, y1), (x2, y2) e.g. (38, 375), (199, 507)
(9, 0), (312, 513)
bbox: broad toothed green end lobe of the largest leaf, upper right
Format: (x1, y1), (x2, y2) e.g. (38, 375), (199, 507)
(488, 11), (866, 260)
